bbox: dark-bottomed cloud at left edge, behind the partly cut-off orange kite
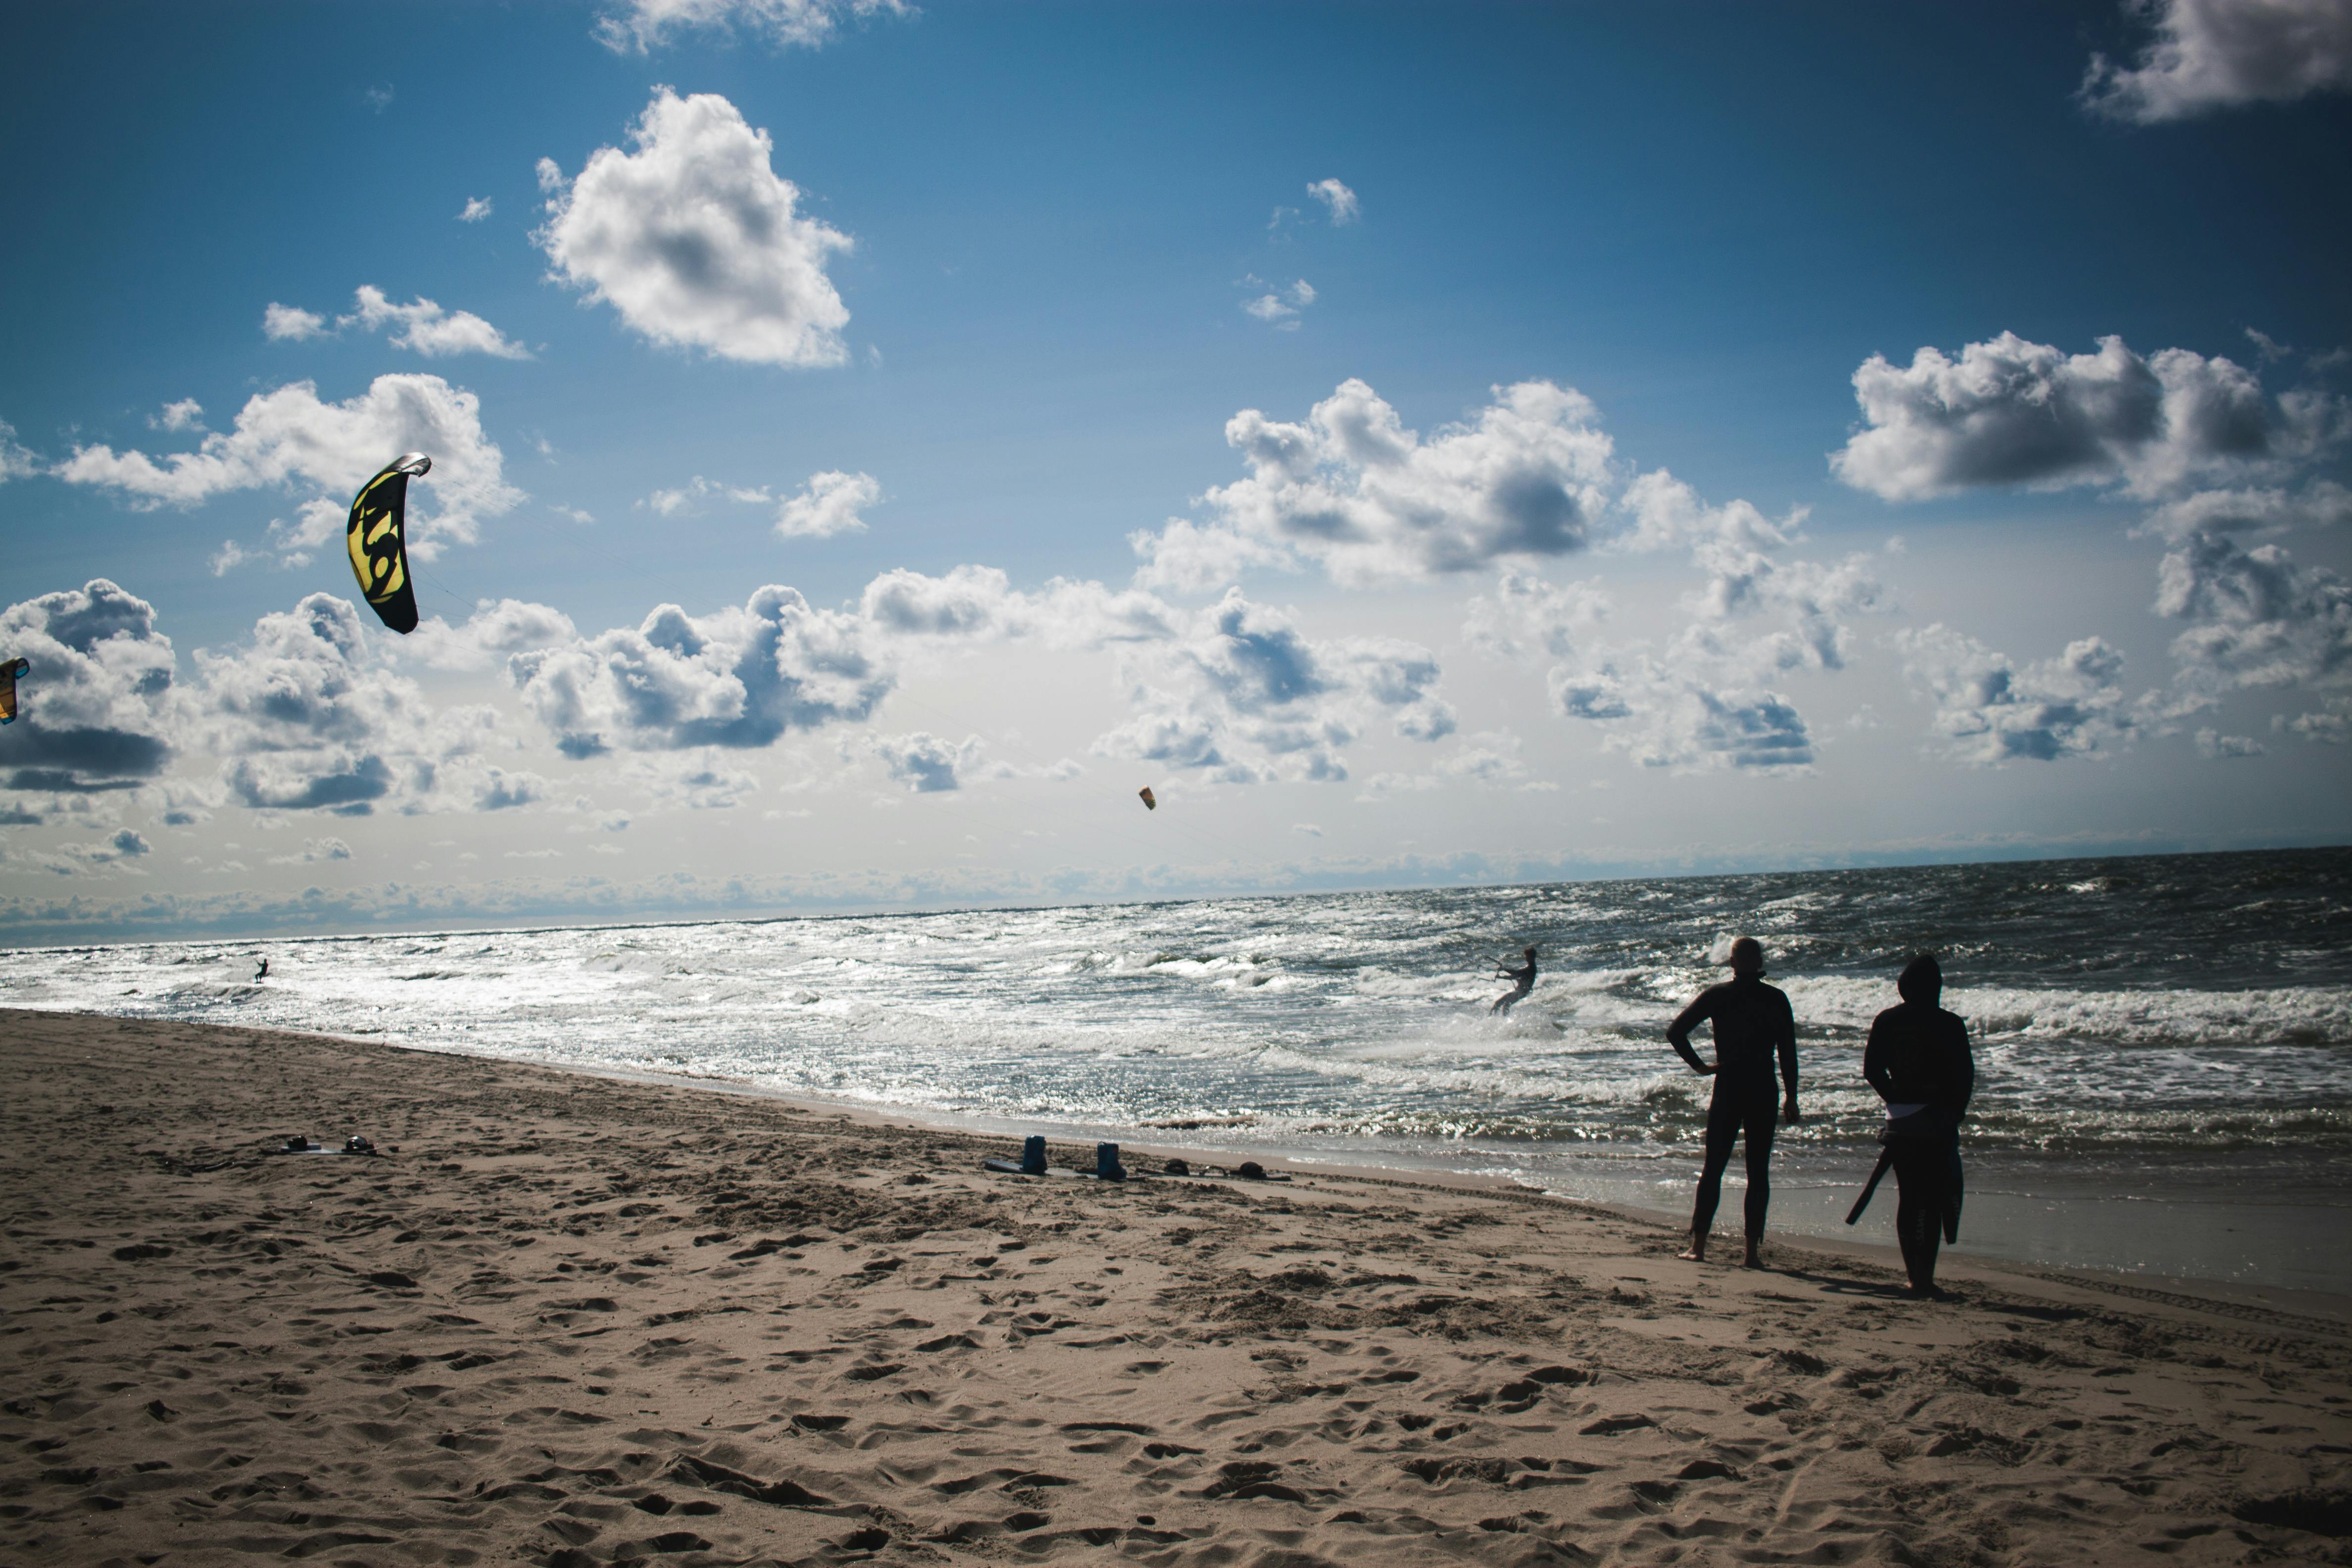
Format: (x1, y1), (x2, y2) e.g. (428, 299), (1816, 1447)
(0, 578), (176, 794)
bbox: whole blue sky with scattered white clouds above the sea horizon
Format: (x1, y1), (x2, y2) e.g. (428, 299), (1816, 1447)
(0, 0), (2352, 940)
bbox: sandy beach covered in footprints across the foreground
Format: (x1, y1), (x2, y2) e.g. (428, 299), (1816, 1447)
(0, 1011), (2352, 1568)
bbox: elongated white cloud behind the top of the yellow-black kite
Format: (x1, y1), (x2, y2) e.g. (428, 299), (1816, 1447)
(54, 374), (522, 559)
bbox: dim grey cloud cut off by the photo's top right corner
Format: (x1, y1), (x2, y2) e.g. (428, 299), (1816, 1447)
(2082, 0), (2352, 125)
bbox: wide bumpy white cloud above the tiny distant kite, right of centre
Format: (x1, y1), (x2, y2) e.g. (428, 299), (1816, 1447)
(1129, 381), (1611, 590)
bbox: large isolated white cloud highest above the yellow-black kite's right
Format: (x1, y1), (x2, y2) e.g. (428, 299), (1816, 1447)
(534, 87), (851, 367)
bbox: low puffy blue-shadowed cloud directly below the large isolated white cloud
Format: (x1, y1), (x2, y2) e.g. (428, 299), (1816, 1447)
(508, 586), (894, 757)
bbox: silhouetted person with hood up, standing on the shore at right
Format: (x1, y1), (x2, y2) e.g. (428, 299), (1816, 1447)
(1863, 952), (1976, 1295)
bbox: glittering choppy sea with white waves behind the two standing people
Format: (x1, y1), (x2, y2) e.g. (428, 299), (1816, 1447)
(0, 849), (2352, 1291)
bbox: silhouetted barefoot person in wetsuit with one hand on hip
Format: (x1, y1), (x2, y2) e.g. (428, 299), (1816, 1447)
(1665, 935), (1799, 1270)
